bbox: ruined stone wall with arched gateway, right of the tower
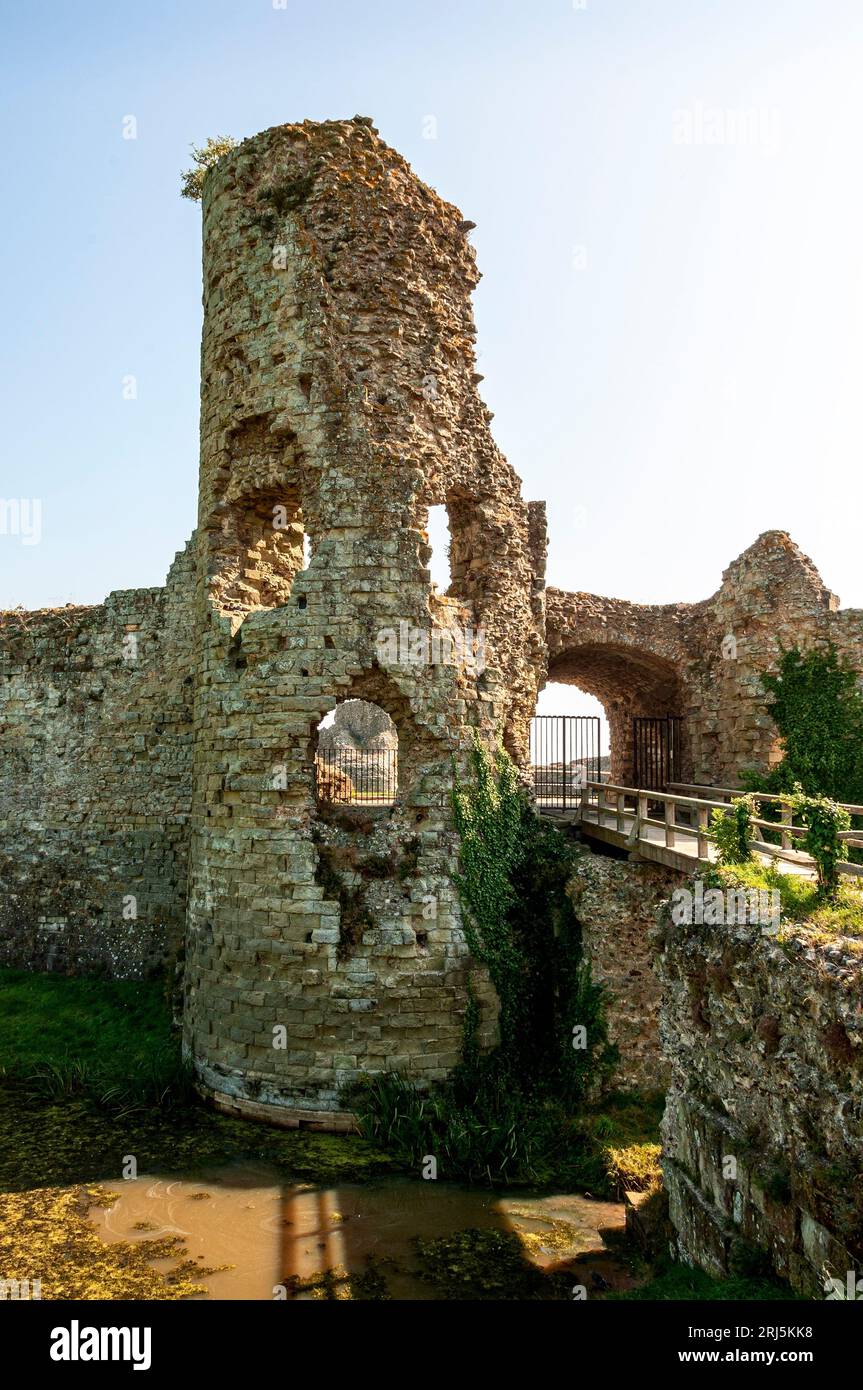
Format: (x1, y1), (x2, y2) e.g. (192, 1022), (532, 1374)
(546, 531), (863, 787)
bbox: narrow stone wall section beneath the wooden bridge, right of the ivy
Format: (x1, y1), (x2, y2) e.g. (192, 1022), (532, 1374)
(567, 848), (681, 1091)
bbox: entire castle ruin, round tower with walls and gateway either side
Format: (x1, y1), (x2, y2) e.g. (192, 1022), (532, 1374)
(0, 117), (863, 1127)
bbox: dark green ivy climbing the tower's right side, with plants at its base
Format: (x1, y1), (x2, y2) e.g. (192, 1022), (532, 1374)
(349, 742), (617, 1187)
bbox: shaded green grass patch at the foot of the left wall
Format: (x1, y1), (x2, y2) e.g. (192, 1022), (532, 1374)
(0, 970), (189, 1105)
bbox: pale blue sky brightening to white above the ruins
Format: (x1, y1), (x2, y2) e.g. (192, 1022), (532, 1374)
(0, 0), (863, 728)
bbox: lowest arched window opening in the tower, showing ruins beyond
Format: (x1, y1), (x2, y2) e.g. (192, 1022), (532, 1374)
(314, 699), (399, 806)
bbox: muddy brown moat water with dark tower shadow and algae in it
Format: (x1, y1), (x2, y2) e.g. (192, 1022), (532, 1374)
(93, 1163), (632, 1300)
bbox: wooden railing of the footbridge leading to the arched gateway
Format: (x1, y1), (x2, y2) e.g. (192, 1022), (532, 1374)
(581, 781), (863, 877)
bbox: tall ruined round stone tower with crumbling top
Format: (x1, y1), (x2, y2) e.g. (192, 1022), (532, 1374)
(185, 117), (545, 1127)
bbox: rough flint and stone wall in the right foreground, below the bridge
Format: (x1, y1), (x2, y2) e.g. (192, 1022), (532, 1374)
(656, 895), (863, 1297)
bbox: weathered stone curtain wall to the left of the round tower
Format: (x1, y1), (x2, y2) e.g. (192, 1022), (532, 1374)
(0, 552), (193, 977)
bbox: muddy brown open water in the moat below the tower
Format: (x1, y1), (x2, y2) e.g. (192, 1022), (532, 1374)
(92, 1163), (632, 1300)
